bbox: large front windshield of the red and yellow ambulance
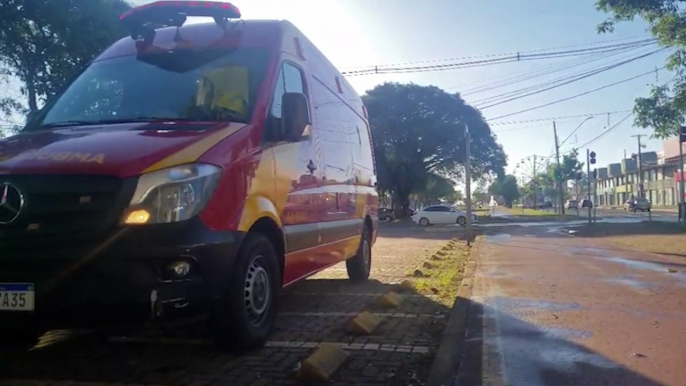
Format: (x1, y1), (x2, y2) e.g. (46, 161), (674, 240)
(33, 48), (268, 129)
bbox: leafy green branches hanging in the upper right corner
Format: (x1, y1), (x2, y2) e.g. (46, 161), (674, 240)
(596, 0), (686, 138)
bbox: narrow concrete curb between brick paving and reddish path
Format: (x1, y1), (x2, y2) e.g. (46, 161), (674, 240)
(426, 236), (483, 386)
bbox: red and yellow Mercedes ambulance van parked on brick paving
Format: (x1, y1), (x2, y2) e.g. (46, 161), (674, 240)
(0, 1), (378, 348)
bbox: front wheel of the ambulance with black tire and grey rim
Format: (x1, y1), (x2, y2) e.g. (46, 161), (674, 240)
(210, 233), (281, 351)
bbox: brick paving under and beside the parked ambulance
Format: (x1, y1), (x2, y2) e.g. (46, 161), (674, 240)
(0, 223), (459, 386)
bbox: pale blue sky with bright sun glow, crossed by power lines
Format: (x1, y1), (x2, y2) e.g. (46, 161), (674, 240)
(16, 0), (671, 176)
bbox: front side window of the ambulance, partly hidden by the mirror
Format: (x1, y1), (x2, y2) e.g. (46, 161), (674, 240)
(263, 62), (306, 143)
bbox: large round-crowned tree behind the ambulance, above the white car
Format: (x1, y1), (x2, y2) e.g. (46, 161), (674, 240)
(363, 83), (506, 217)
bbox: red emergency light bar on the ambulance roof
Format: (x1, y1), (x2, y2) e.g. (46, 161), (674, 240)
(119, 1), (241, 28)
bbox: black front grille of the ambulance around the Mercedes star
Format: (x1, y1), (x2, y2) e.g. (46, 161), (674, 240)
(0, 175), (136, 249)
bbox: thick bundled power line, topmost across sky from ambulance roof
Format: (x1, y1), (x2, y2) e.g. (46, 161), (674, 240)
(342, 39), (654, 76)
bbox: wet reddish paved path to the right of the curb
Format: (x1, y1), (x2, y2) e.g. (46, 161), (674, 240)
(455, 225), (686, 386)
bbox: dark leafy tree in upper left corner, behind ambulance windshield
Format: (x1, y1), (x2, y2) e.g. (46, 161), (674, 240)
(0, 0), (130, 116)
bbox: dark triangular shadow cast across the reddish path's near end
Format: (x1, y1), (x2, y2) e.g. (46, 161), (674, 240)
(460, 300), (662, 386)
